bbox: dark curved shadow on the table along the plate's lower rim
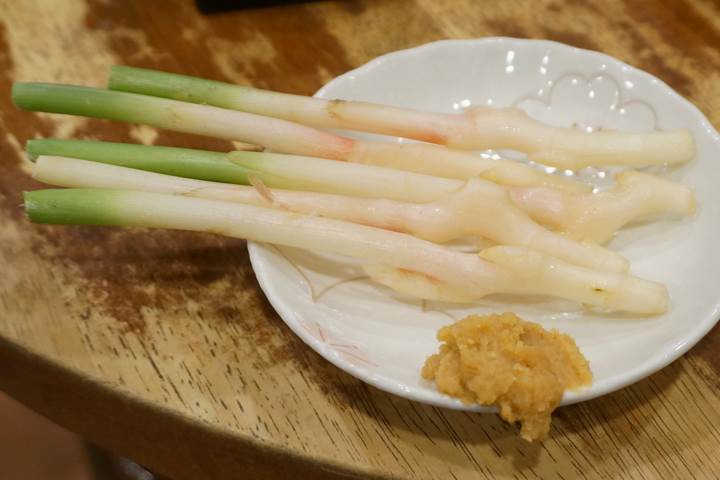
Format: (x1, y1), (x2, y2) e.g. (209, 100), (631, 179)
(236, 280), (682, 476)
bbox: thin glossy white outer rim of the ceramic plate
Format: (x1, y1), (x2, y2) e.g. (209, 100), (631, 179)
(247, 37), (720, 412)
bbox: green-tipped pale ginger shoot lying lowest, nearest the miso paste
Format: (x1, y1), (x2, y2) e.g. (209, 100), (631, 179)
(24, 189), (668, 315)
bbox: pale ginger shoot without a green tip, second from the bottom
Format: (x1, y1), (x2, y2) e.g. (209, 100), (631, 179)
(33, 156), (628, 272)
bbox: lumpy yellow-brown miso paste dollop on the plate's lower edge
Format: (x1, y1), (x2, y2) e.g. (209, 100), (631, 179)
(422, 313), (592, 441)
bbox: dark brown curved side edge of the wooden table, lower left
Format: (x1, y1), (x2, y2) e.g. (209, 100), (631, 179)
(0, 333), (394, 480)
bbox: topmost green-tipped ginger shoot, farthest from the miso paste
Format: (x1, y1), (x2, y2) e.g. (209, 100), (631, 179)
(109, 66), (695, 169)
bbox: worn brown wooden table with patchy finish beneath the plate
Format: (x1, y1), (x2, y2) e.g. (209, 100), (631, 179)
(0, 0), (720, 479)
